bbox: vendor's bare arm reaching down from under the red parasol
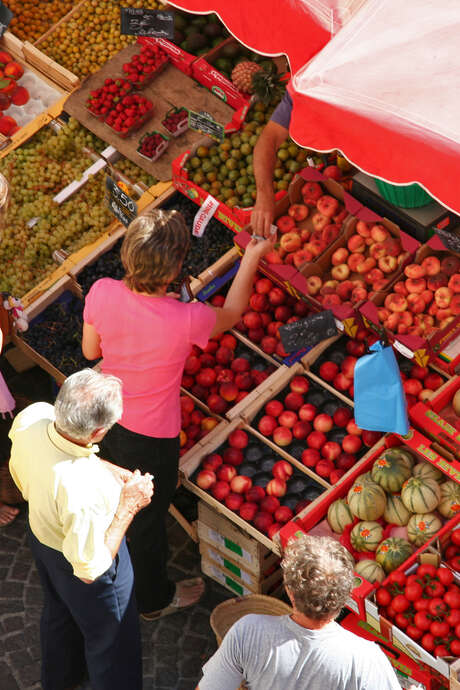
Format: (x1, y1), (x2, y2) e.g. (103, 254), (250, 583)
(251, 120), (289, 237)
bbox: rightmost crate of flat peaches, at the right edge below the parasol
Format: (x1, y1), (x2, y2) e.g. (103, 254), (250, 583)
(360, 236), (460, 356)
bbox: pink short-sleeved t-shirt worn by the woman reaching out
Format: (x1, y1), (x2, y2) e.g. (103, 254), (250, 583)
(83, 278), (216, 438)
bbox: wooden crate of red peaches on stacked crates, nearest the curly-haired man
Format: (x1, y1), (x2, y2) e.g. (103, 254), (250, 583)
(181, 419), (325, 549)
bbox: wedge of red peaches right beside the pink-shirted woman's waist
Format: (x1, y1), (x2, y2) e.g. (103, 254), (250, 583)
(179, 393), (227, 461)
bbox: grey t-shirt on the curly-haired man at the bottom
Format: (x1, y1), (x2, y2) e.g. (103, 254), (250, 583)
(199, 614), (401, 690)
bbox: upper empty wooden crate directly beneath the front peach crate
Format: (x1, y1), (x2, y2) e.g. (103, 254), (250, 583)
(197, 501), (279, 580)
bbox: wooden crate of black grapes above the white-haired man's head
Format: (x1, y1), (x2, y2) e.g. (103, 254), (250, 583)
(13, 278), (91, 385)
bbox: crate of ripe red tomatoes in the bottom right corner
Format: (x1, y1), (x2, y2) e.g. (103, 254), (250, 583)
(365, 515), (460, 689)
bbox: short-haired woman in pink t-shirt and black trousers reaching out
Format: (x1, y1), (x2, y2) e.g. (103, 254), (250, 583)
(82, 210), (273, 620)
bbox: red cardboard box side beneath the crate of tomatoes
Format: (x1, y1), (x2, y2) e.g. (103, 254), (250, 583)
(340, 613), (448, 690)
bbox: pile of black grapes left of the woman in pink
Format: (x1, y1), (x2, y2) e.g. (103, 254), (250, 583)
(22, 293), (96, 376)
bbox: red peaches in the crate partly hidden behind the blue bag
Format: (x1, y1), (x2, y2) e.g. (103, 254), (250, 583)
(302, 329), (447, 409)
